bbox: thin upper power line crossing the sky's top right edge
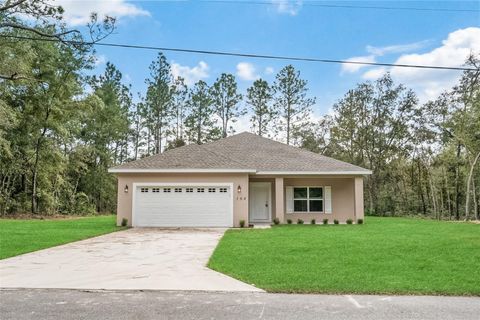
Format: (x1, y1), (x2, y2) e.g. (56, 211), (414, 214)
(200, 0), (480, 13)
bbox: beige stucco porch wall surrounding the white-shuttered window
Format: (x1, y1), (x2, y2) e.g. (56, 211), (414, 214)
(284, 177), (363, 223)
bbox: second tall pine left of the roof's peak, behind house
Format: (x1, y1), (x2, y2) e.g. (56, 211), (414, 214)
(185, 80), (221, 144)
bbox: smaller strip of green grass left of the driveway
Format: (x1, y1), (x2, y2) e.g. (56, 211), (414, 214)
(0, 215), (124, 259)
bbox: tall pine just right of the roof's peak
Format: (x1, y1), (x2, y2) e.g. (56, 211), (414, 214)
(246, 79), (276, 136)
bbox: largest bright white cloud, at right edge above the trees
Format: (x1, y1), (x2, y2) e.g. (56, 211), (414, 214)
(363, 27), (480, 102)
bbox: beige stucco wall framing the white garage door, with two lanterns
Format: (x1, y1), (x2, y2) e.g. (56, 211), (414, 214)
(117, 173), (248, 227)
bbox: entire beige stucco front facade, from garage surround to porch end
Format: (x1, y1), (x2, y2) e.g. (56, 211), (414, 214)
(117, 173), (364, 227)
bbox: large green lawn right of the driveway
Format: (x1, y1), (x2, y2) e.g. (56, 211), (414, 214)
(209, 217), (480, 296)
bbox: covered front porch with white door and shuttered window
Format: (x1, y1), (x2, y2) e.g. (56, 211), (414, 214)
(248, 175), (364, 227)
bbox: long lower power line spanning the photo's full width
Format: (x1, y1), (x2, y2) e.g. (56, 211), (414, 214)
(0, 35), (478, 71)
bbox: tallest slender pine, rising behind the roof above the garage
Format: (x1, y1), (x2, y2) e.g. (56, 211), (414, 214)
(145, 52), (172, 154)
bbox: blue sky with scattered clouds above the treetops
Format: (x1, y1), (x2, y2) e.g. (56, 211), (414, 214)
(57, 0), (480, 129)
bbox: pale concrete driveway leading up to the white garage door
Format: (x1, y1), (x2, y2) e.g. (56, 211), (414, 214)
(0, 228), (262, 291)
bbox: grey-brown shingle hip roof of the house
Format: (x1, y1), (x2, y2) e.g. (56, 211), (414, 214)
(110, 132), (370, 174)
